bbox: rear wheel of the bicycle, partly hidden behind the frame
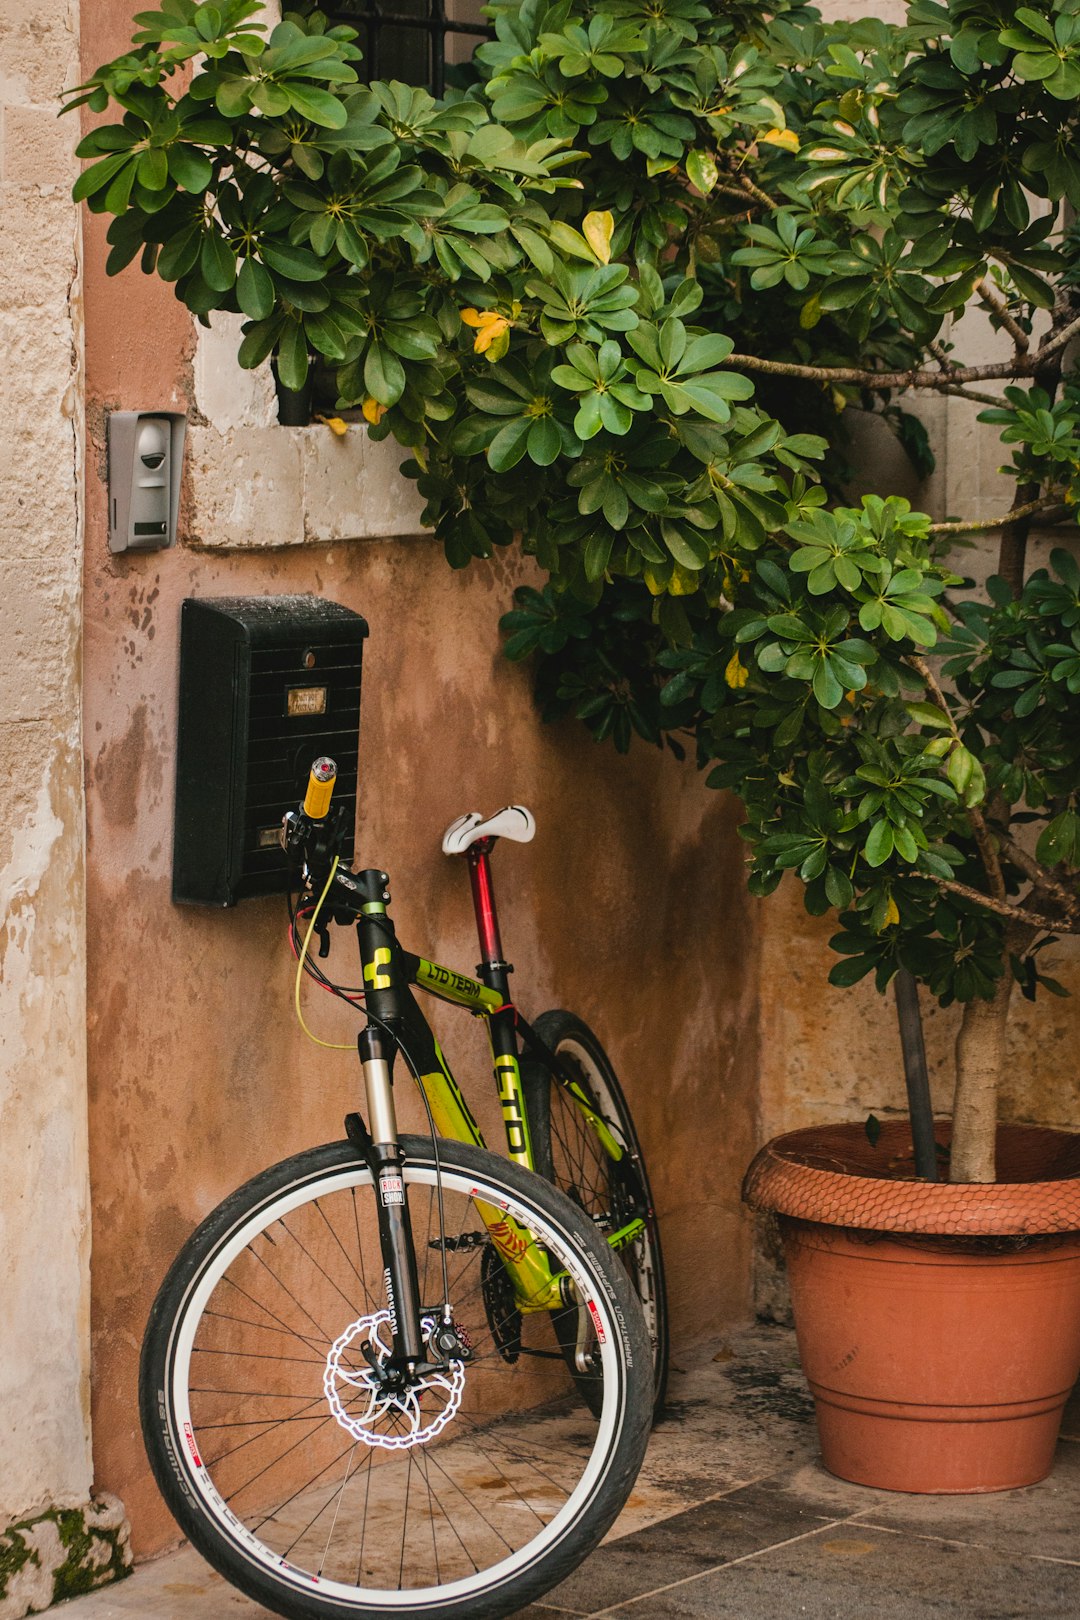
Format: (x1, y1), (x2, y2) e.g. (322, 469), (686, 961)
(521, 1009), (670, 1416)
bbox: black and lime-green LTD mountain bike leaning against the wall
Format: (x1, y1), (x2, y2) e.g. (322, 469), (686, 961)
(139, 760), (661, 1620)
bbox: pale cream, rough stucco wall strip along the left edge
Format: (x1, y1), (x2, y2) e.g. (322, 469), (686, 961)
(0, 0), (91, 1523)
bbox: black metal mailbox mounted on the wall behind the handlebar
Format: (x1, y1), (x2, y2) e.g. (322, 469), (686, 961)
(173, 596), (368, 906)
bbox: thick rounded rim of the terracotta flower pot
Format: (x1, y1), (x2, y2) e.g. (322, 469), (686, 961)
(742, 1119), (1080, 1236)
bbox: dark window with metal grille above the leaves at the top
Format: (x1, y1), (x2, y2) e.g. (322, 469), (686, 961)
(316, 0), (492, 96)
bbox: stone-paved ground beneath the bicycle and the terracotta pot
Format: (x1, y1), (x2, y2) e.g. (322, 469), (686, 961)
(55, 1327), (1080, 1620)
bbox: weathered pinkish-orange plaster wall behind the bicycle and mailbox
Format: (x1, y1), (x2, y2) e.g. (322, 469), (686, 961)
(84, 0), (756, 1554)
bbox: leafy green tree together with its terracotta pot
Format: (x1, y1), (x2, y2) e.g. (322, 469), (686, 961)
(71, 0), (1080, 1489)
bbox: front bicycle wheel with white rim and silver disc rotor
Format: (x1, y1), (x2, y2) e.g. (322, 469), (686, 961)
(139, 1137), (649, 1620)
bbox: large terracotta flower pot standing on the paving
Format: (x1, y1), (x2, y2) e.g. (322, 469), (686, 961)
(743, 1121), (1080, 1492)
